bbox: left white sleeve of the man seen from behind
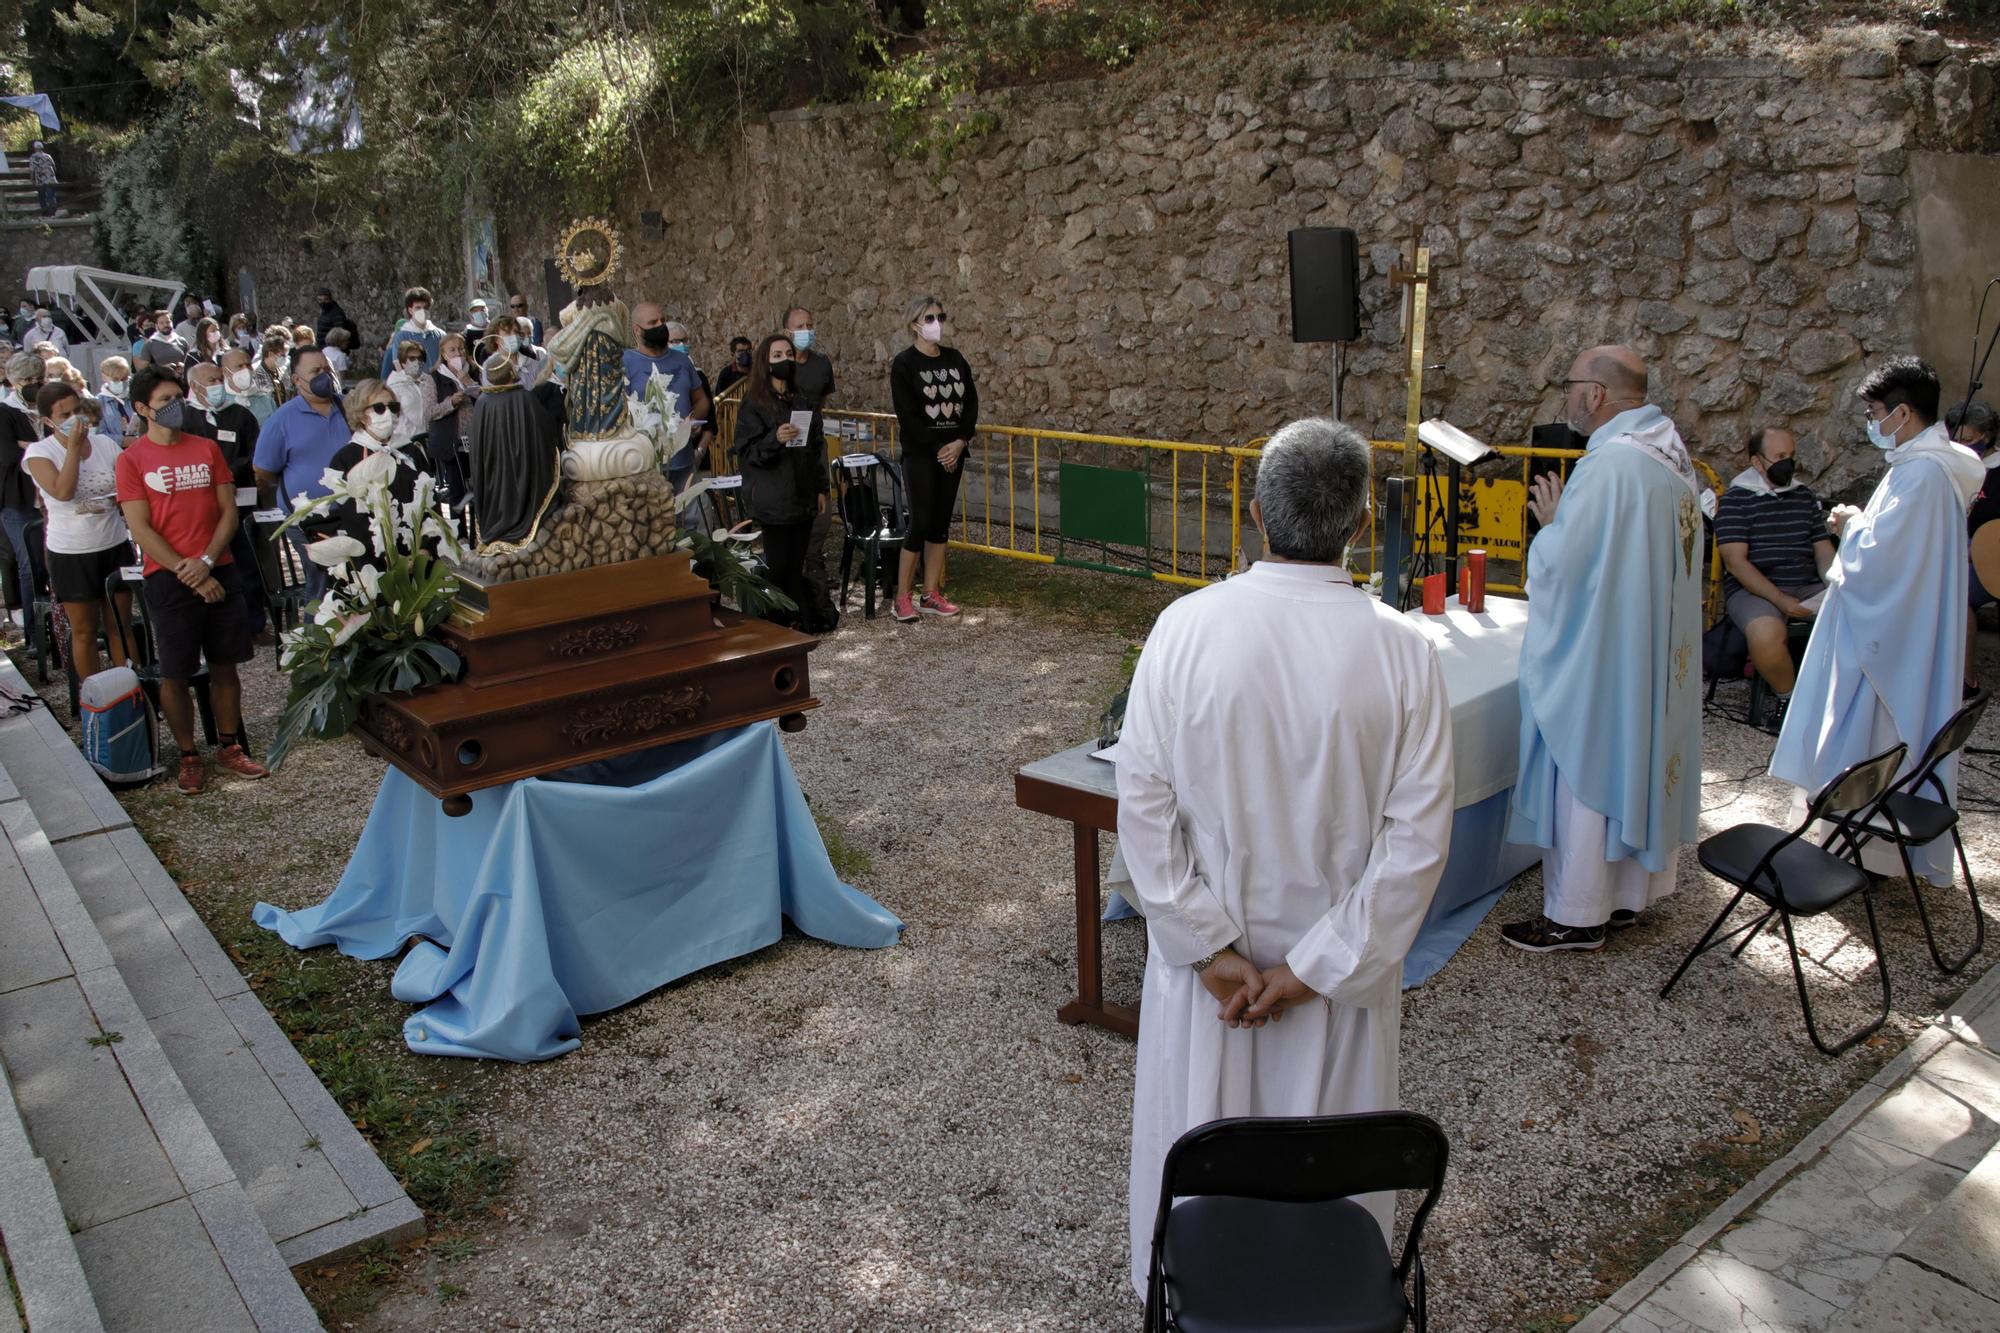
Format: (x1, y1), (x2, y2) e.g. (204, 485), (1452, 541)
(1118, 626), (1242, 967)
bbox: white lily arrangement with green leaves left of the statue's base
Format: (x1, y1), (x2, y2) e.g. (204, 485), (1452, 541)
(268, 452), (462, 769)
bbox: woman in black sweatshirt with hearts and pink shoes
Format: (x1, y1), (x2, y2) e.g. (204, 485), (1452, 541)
(888, 296), (980, 622)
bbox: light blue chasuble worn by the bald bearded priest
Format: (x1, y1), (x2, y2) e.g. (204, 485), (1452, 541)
(1508, 406), (1704, 871)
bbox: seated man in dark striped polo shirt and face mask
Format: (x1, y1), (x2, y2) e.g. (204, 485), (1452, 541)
(1716, 426), (1834, 731)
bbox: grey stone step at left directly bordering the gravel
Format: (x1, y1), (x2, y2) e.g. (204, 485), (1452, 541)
(0, 658), (424, 1265)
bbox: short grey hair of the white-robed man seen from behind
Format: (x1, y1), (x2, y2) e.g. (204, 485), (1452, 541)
(1256, 416), (1372, 564)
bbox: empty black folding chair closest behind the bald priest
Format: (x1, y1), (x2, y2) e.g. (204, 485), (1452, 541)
(1660, 745), (1908, 1055)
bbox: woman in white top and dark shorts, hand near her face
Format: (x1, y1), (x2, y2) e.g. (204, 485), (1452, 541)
(24, 384), (136, 681)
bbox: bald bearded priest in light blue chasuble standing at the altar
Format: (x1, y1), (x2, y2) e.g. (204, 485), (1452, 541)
(1500, 346), (1702, 953)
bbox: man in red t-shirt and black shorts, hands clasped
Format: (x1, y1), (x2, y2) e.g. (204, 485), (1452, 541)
(118, 366), (270, 797)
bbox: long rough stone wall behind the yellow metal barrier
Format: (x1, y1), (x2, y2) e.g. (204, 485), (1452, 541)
(488, 30), (2000, 488)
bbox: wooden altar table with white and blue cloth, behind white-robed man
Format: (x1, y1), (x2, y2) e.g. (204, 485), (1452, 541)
(1014, 596), (1542, 1037)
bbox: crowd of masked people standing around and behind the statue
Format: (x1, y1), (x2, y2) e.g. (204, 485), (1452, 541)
(0, 276), (978, 793)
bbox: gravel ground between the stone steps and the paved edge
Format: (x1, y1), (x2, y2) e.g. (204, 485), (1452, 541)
(23, 592), (2000, 1329)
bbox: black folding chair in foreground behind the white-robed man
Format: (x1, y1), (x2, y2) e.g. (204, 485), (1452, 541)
(1146, 1111), (1450, 1333)
